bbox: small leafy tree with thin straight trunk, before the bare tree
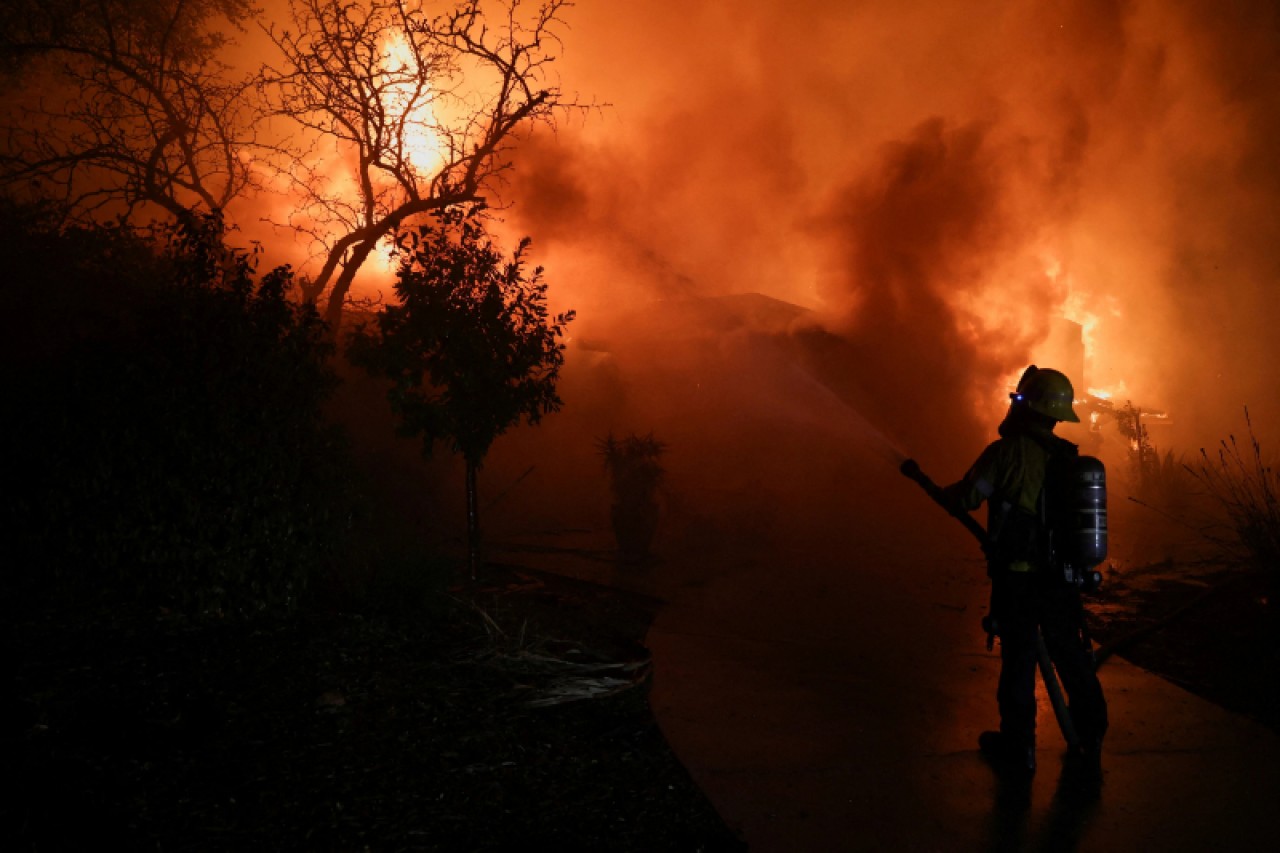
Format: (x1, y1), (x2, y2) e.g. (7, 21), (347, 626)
(349, 209), (573, 578)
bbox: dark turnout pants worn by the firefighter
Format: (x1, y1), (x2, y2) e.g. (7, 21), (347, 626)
(992, 570), (1107, 747)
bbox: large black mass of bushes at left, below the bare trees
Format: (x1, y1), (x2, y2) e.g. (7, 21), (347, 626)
(0, 199), (351, 612)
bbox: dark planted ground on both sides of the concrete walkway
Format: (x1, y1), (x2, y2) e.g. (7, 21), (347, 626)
(0, 555), (1280, 850)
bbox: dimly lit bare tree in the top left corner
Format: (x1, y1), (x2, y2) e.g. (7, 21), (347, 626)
(0, 0), (255, 219)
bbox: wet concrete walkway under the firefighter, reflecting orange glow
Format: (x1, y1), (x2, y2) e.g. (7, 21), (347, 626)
(649, 530), (1280, 853)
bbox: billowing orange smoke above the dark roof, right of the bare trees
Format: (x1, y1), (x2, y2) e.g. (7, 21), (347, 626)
(506, 1), (1280, 462)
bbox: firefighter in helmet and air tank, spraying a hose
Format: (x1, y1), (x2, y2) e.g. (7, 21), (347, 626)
(943, 365), (1107, 772)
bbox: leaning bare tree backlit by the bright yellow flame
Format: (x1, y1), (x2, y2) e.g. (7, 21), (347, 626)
(262, 0), (568, 328)
